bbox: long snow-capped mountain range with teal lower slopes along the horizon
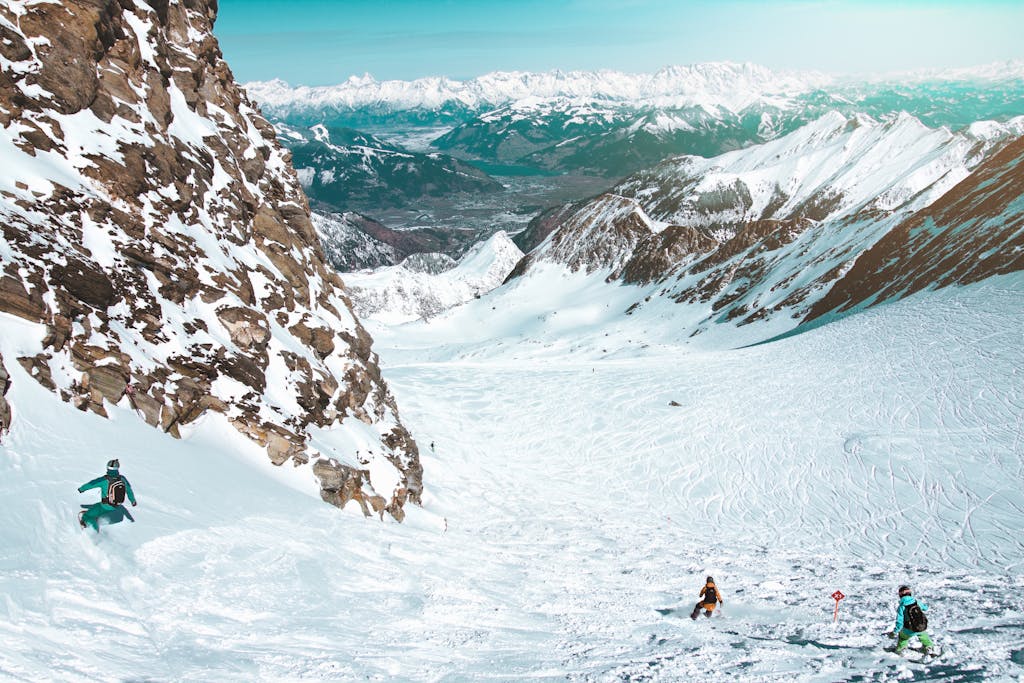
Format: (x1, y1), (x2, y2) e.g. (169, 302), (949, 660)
(247, 61), (1024, 178)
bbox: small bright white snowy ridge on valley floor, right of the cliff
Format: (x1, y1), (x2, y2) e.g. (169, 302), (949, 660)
(345, 230), (522, 324)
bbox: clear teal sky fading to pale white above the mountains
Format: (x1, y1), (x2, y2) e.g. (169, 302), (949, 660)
(215, 0), (1024, 85)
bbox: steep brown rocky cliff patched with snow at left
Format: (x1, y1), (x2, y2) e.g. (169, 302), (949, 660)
(0, 0), (421, 518)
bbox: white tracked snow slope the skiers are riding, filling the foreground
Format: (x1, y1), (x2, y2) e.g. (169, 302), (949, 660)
(0, 278), (1024, 681)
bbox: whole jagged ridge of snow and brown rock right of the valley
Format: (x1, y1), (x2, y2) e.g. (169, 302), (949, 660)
(513, 113), (1024, 344)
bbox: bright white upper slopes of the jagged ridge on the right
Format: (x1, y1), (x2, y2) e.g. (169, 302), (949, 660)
(620, 112), (1024, 225)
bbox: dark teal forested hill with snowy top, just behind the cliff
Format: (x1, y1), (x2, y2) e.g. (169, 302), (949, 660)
(276, 124), (502, 211)
